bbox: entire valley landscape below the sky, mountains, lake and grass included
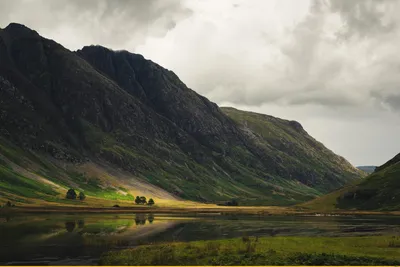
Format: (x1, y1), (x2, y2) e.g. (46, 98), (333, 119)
(0, 23), (400, 265)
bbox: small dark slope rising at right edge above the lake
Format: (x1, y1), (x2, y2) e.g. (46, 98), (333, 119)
(304, 154), (400, 211)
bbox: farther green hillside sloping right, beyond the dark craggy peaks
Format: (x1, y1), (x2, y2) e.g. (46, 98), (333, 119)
(222, 108), (362, 193)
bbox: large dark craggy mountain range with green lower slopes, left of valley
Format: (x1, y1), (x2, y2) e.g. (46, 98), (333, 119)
(0, 23), (362, 205)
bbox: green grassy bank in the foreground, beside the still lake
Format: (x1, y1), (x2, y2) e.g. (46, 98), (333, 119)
(100, 236), (400, 265)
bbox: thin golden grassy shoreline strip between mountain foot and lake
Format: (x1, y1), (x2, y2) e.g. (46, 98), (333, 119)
(0, 206), (400, 216)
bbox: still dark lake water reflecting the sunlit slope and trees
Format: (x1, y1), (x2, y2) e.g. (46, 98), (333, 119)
(0, 214), (400, 265)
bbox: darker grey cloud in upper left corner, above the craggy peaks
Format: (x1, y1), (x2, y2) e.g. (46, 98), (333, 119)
(0, 0), (192, 48)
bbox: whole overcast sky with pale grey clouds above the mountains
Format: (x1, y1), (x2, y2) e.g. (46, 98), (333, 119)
(0, 0), (400, 166)
